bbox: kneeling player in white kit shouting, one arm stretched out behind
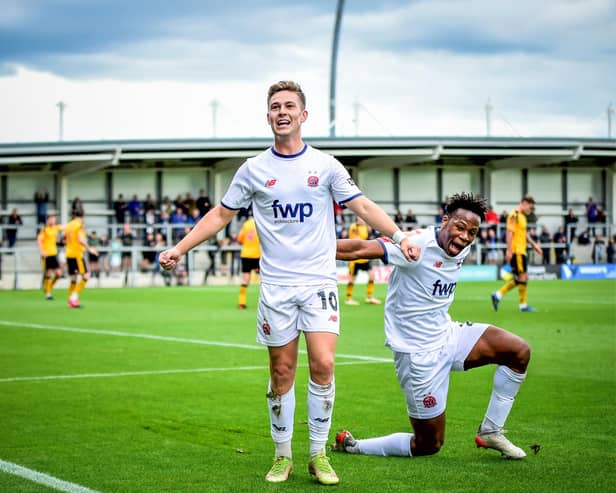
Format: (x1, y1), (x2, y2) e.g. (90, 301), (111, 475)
(334, 193), (530, 459)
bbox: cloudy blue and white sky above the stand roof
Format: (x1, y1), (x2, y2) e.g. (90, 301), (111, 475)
(0, 0), (616, 143)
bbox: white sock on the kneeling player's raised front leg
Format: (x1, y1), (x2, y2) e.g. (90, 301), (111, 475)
(480, 366), (526, 433)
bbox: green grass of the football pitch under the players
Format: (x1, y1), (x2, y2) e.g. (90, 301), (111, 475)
(0, 281), (616, 493)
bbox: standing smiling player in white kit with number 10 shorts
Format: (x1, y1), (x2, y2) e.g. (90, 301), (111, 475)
(160, 81), (418, 484)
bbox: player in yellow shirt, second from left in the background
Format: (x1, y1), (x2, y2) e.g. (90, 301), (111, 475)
(64, 210), (97, 308)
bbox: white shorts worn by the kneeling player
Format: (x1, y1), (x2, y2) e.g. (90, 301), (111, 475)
(394, 321), (488, 419)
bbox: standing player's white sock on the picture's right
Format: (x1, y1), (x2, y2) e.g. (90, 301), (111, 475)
(308, 378), (336, 457)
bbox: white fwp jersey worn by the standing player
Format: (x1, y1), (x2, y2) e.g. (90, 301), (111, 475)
(221, 145), (361, 286)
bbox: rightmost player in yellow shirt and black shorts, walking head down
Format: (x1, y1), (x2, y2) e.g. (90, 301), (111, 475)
(492, 195), (543, 312)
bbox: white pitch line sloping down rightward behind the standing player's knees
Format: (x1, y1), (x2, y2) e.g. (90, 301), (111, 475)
(0, 320), (391, 363)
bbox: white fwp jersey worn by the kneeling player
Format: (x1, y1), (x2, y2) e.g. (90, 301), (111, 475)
(381, 226), (470, 353)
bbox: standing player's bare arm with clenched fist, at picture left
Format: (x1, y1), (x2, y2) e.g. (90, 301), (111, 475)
(158, 204), (237, 270)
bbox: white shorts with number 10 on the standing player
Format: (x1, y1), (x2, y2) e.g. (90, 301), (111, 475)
(257, 281), (340, 347)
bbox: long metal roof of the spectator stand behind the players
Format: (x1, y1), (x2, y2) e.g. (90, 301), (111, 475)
(0, 137), (616, 176)
